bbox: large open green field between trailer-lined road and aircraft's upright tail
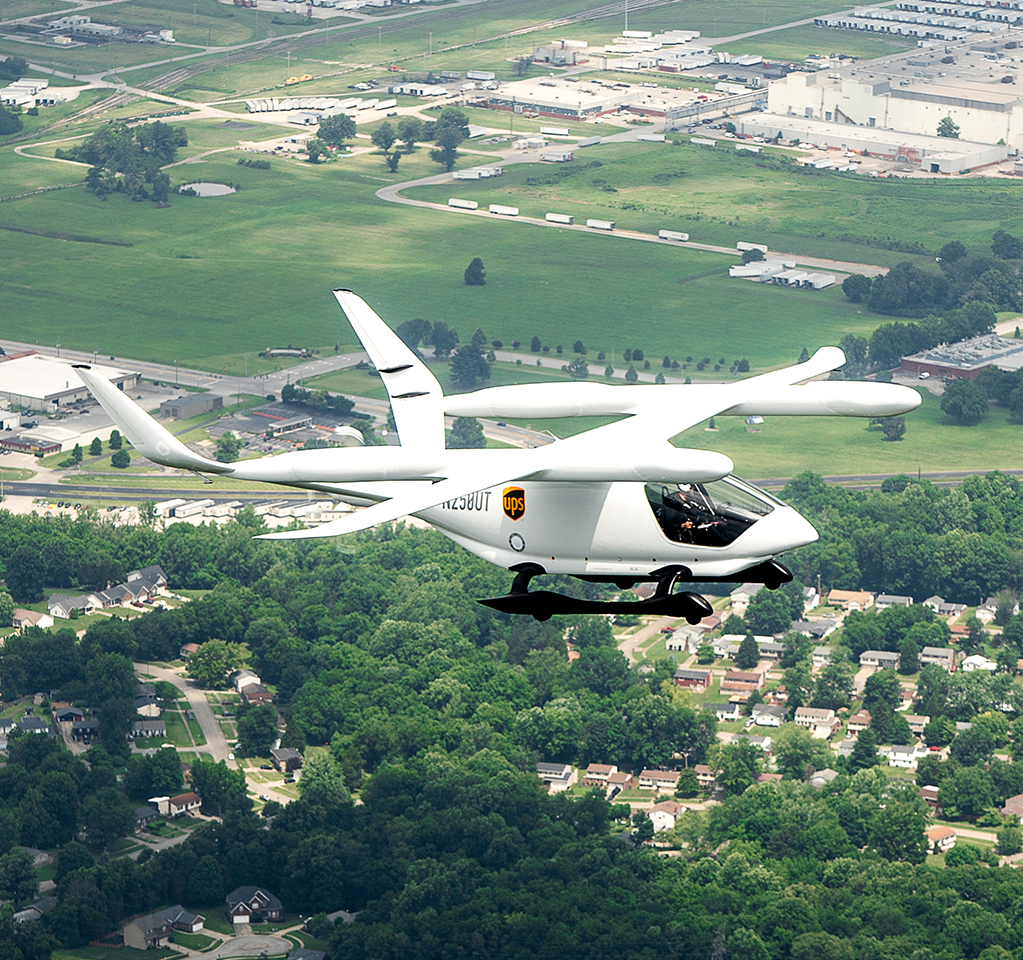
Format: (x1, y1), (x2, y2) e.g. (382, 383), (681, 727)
(0, 142), (880, 374)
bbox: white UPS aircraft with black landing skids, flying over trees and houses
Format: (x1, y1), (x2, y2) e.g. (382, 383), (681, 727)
(76, 290), (921, 623)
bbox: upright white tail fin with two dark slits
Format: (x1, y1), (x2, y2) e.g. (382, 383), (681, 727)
(333, 290), (444, 450)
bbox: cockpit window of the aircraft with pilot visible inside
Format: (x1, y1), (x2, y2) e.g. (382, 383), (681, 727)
(647, 477), (781, 547)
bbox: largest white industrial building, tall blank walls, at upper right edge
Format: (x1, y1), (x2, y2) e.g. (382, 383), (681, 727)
(767, 27), (1023, 149)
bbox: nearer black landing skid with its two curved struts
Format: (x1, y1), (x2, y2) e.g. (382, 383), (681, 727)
(479, 563), (714, 623)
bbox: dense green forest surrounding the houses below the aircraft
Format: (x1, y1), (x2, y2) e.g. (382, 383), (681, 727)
(0, 474), (1023, 960)
